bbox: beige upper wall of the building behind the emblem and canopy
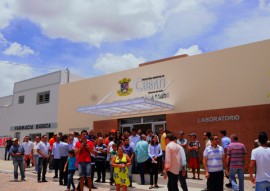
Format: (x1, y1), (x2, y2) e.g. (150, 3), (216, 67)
(58, 40), (270, 132)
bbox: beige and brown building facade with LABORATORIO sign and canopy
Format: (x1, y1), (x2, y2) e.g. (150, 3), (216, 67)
(58, 40), (270, 161)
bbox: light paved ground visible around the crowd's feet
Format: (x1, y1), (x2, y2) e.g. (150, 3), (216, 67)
(0, 159), (254, 191)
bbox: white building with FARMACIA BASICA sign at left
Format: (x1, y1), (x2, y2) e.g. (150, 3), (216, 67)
(0, 70), (82, 156)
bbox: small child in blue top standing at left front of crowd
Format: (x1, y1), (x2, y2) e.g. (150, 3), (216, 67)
(64, 150), (76, 191)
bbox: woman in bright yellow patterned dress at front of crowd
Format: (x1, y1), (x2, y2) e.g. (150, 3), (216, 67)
(112, 147), (131, 191)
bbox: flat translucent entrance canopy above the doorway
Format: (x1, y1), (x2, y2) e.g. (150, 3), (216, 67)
(77, 98), (173, 116)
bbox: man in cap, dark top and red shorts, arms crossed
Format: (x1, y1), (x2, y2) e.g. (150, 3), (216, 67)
(187, 133), (202, 180)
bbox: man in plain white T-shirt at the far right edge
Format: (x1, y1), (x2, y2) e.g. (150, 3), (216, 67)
(250, 132), (270, 191)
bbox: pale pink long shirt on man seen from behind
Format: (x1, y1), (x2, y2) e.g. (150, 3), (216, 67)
(165, 141), (181, 175)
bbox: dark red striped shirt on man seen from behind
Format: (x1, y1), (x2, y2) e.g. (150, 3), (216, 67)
(227, 142), (247, 169)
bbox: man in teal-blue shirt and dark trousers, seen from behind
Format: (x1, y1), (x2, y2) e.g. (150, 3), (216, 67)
(134, 134), (149, 185)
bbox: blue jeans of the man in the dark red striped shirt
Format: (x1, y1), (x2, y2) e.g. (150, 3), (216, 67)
(229, 168), (244, 191)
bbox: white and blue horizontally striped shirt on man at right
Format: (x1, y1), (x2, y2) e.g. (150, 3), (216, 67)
(203, 145), (224, 172)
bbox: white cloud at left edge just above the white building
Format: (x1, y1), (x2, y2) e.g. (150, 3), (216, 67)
(0, 60), (33, 97)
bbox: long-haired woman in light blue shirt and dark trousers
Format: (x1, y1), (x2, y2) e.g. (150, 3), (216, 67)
(148, 135), (162, 189)
